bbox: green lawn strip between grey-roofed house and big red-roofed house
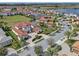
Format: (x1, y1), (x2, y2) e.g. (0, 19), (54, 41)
(6, 31), (22, 49)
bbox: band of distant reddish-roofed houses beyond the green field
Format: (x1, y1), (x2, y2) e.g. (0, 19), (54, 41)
(0, 6), (58, 16)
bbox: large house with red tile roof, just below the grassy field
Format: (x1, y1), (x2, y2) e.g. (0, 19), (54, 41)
(12, 22), (40, 39)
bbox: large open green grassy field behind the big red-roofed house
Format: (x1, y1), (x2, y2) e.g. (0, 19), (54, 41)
(0, 15), (32, 26)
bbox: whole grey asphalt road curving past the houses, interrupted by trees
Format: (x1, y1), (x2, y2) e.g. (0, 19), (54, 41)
(19, 20), (69, 56)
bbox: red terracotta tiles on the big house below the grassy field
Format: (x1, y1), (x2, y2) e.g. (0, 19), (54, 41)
(12, 22), (40, 36)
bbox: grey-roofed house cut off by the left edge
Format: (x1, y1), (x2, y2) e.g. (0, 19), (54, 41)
(0, 28), (12, 48)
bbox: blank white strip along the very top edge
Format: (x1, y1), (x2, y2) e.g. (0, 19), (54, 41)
(0, 0), (79, 2)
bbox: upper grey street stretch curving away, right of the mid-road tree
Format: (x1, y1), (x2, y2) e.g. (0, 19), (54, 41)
(52, 19), (69, 45)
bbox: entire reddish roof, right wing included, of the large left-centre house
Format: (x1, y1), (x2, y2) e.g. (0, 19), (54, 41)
(12, 22), (40, 36)
